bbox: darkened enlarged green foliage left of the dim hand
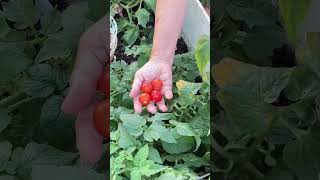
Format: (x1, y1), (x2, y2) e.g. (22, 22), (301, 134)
(0, 0), (108, 180)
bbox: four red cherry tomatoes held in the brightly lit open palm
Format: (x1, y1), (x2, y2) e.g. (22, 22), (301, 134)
(139, 79), (163, 106)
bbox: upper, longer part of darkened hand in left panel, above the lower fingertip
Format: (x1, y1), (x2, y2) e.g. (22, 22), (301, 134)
(62, 16), (109, 114)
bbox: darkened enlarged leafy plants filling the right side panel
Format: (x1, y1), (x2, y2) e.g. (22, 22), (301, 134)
(211, 0), (320, 180)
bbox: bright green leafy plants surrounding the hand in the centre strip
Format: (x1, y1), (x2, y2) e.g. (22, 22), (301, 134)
(110, 0), (210, 180)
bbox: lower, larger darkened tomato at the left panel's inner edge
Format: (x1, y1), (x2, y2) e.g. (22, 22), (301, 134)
(93, 100), (110, 139)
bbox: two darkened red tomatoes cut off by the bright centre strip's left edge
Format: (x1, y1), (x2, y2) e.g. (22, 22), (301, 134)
(93, 72), (110, 139)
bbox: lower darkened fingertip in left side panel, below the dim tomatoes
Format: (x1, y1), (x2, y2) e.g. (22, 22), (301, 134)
(76, 102), (103, 164)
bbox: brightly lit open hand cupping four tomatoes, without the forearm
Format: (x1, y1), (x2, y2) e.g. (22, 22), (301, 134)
(130, 58), (173, 114)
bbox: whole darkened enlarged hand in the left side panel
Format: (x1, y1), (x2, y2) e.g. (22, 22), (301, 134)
(62, 17), (109, 164)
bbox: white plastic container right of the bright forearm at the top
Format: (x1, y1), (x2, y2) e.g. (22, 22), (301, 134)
(182, 0), (210, 51)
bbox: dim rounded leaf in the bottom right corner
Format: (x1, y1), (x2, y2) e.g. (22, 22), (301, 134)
(283, 135), (320, 180)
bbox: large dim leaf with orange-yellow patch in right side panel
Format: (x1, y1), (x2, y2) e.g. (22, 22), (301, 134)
(213, 59), (292, 134)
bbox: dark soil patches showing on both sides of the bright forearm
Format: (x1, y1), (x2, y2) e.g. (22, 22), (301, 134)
(114, 35), (188, 64)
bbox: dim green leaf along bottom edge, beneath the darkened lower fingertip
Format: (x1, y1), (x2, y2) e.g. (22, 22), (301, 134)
(31, 165), (106, 180)
